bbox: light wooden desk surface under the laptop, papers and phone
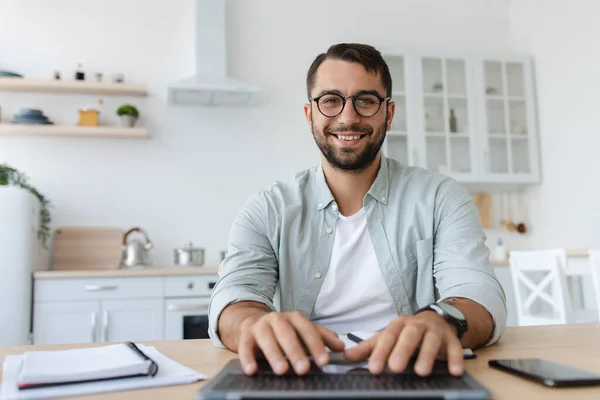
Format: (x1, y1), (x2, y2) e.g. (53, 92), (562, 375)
(0, 323), (600, 400)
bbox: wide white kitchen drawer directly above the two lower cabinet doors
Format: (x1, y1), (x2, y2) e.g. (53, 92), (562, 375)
(34, 277), (164, 302)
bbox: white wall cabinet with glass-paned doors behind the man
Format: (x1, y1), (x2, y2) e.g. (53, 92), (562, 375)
(383, 52), (539, 184)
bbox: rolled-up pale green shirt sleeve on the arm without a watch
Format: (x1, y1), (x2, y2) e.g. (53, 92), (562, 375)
(208, 195), (278, 347)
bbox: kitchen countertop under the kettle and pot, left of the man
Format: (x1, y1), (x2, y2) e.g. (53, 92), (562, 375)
(33, 266), (219, 279)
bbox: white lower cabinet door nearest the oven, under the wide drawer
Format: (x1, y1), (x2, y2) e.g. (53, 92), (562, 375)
(100, 298), (164, 342)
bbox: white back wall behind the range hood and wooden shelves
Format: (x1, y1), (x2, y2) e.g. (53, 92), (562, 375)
(0, 0), (510, 266)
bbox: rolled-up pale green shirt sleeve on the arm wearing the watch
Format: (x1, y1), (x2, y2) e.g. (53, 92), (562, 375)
(433, 179), (506, 345)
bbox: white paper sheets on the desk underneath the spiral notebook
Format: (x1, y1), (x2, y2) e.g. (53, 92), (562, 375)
(0, 345), (206, 400)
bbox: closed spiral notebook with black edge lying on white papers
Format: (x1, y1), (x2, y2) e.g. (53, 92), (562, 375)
(18, 342), (158, 389)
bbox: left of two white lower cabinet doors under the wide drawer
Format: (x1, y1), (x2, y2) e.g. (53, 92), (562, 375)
(33, 301), (100, 344)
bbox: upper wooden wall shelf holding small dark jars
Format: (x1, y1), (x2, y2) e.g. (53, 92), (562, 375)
(0, 77), (148, 97)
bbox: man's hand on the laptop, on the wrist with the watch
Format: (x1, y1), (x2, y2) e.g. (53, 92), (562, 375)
(345, 311), (464, 376)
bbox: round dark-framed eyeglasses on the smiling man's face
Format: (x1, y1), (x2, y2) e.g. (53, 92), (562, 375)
(309, 93), (390, 118)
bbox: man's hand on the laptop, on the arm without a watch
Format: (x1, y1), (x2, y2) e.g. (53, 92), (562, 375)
(238, 311), (344, 375)
